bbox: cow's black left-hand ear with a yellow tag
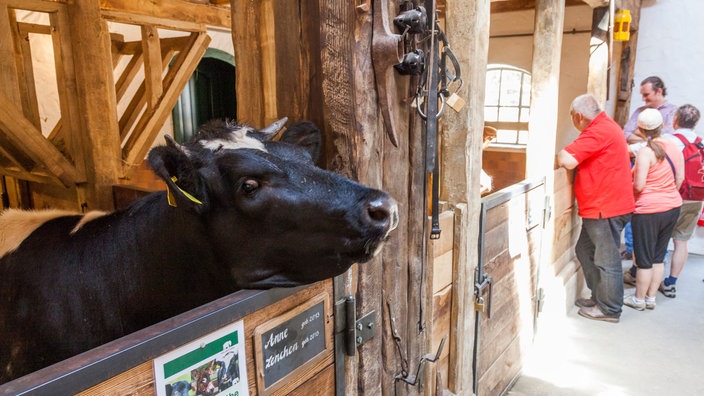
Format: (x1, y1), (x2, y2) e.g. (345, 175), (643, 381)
(147, 137), (207, 213)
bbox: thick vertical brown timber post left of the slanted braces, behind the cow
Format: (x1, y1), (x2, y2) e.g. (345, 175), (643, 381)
(68, 0), (121, 210)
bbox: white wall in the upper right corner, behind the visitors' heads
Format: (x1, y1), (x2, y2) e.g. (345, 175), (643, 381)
(630, 0), (704, 114)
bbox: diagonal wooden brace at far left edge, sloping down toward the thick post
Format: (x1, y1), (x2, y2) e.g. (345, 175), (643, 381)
(0, 93), (78, 187)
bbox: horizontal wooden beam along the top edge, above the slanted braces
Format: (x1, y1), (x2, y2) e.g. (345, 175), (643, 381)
(100, 0), (232, 31)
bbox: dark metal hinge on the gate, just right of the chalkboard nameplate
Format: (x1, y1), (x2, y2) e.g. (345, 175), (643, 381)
(335, 296), (376, 356)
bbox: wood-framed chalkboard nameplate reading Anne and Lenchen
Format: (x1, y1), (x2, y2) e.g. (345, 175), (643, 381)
(254, 293), (332, 395)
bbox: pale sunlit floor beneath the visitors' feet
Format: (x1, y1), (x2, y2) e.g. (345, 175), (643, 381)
(506, 232), (704, 396)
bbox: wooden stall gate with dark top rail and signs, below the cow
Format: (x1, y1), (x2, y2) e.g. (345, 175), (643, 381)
(0, 280), (335, 396)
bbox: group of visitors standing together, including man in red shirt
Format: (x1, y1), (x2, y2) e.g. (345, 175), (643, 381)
(557, 76), (704, 323)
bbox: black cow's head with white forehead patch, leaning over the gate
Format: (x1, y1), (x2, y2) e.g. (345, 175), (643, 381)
(149, 120), (398, 288)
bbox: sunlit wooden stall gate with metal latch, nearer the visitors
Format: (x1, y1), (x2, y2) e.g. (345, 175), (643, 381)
(473, 179), (546, 396)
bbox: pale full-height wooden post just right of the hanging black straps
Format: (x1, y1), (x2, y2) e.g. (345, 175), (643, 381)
(441, 1), (490, 395)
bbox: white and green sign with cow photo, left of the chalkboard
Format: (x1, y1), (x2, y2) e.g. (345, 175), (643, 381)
(154, 321), (249, 396)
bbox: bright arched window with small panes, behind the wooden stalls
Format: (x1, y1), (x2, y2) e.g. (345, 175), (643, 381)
(484, 64), (531, 148)
